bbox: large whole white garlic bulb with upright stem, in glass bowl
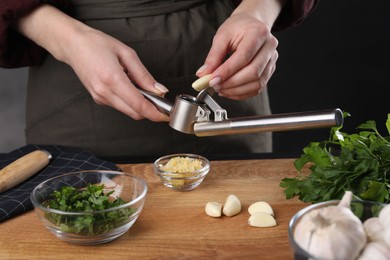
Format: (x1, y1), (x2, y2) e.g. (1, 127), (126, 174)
(294, 192), (367, 260)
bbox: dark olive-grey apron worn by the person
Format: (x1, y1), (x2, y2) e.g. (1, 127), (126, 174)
(26, 0), (272, 156)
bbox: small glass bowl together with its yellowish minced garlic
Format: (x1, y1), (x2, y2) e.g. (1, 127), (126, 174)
(153, 153), (210, 191)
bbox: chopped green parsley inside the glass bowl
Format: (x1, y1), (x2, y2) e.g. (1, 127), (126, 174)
(45, 184), (135, 235)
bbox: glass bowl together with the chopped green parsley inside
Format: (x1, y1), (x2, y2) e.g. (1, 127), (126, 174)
(30, 170), (148, 245)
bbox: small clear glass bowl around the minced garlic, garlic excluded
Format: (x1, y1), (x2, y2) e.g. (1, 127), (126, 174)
(153, 154), (210, 191)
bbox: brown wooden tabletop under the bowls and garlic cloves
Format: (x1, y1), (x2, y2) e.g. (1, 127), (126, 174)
(0, 159), (306, 259)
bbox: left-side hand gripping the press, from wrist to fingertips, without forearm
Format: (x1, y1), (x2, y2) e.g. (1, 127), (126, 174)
(62, 26), (169, 121)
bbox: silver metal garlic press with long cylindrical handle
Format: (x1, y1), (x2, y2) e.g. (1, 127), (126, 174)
(140, 87), (343, 136)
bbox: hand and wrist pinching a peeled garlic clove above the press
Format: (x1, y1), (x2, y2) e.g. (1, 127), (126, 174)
(197, 0), (283, 100)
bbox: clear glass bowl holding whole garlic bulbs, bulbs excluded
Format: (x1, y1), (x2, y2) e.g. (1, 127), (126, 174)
(288, 200), (386, 260)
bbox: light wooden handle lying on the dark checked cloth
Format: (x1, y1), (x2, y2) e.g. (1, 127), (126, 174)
(0, 150), (51, 193)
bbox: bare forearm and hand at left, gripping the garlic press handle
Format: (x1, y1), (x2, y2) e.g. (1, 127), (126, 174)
(17, 5), (169, 122)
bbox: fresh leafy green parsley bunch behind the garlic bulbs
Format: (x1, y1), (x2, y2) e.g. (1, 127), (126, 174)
(280, 113), (390, 203)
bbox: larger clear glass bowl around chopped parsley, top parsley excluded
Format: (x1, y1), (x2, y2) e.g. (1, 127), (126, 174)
(30, 170), (147, 245)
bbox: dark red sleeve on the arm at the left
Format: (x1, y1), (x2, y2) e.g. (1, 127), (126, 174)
(0, 0), (69, 68)
